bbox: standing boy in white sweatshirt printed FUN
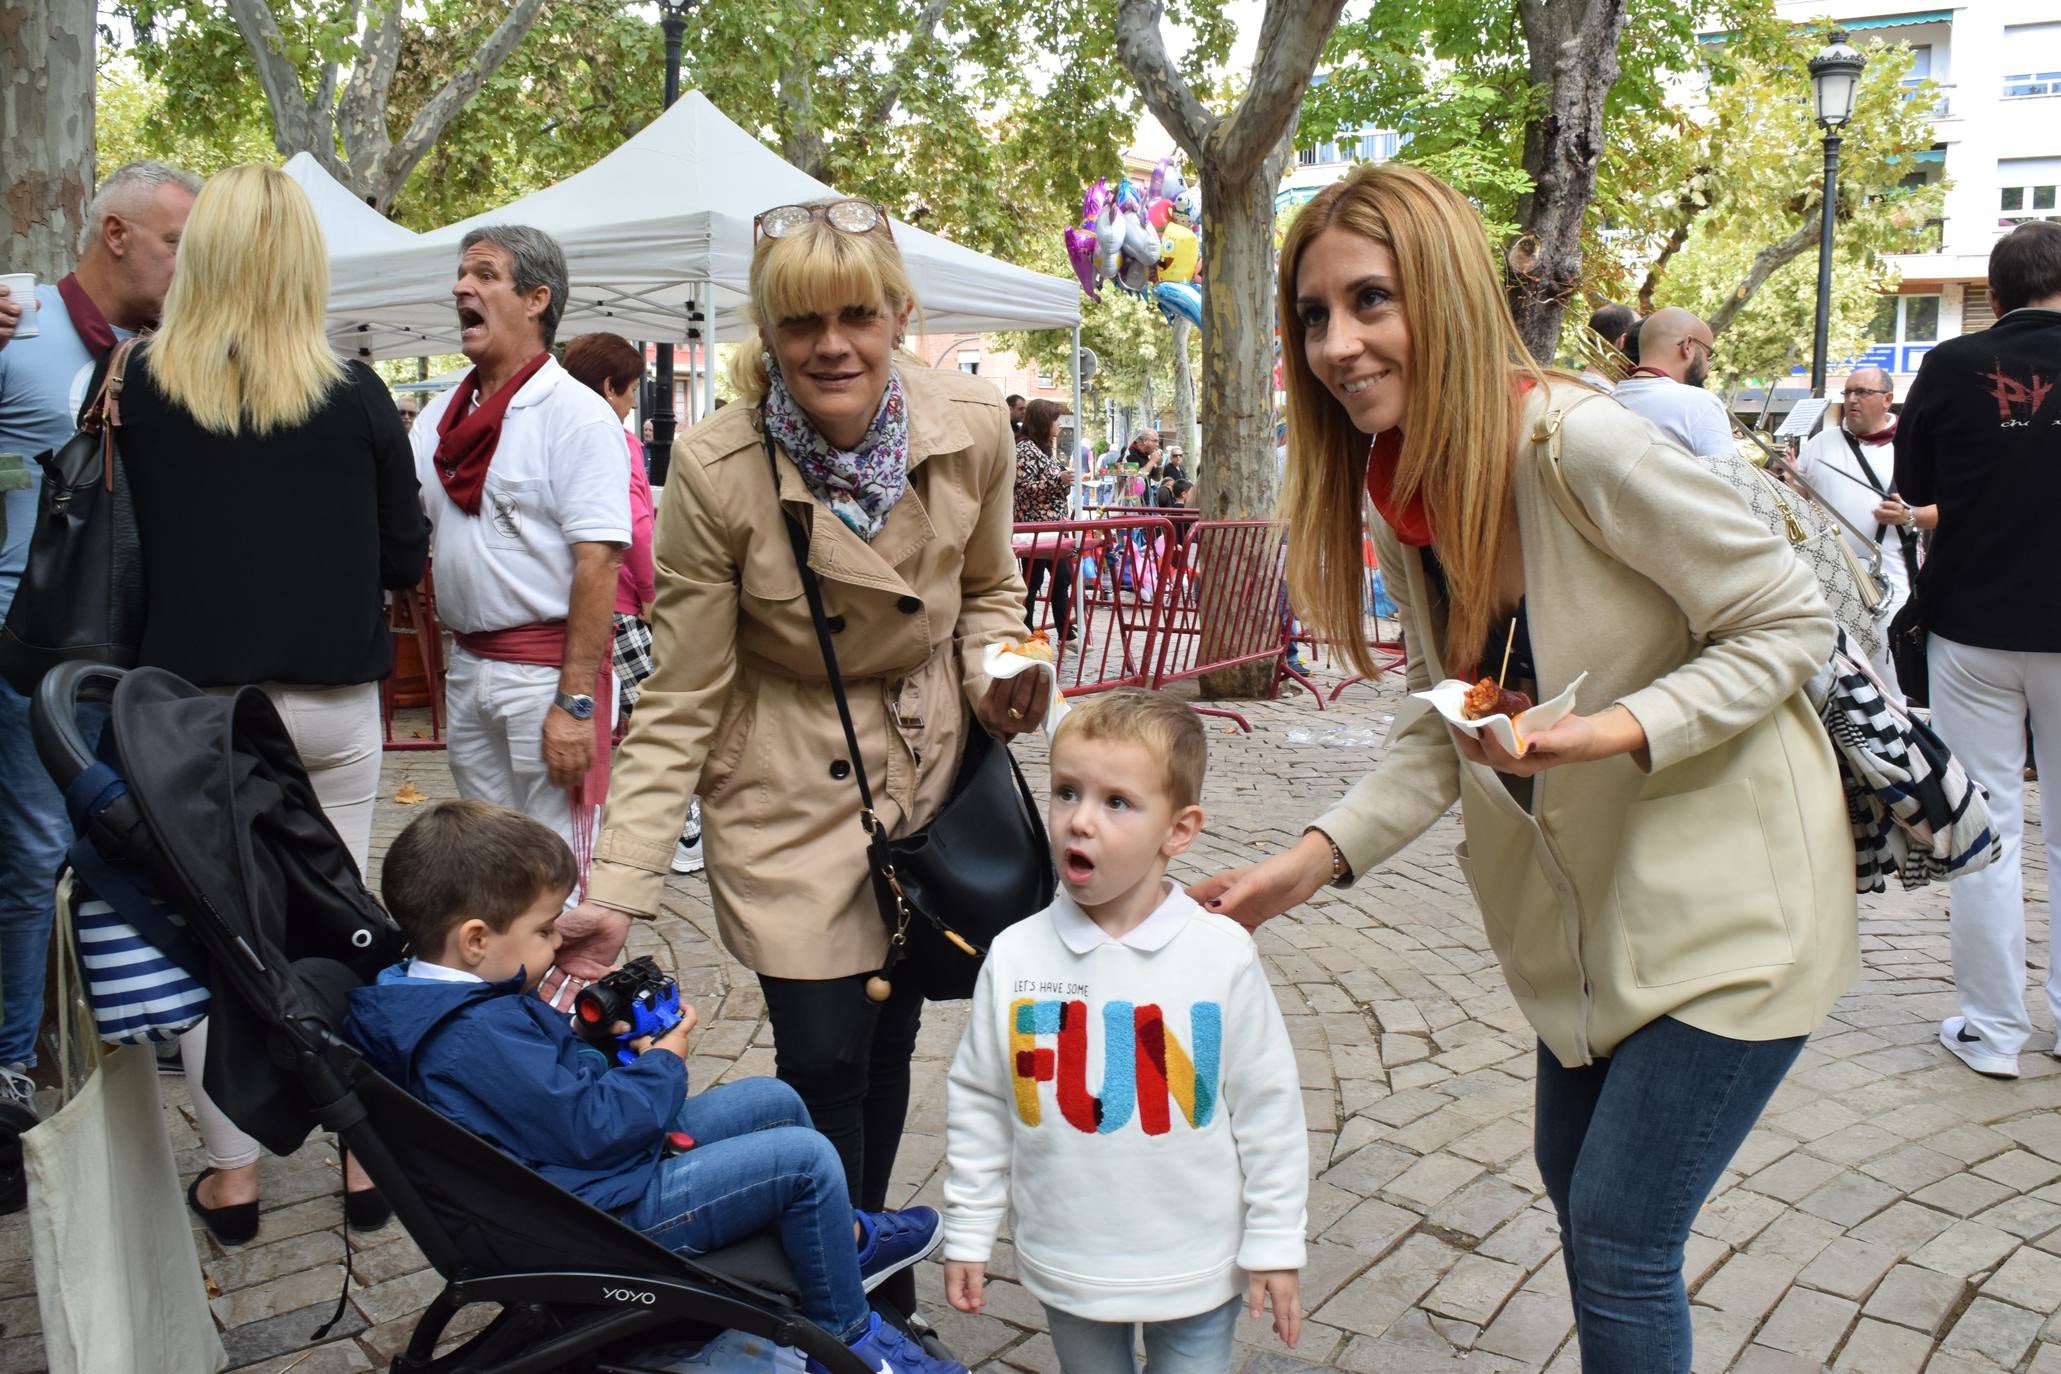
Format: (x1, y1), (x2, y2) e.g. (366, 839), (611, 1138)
(944, 688), (1309, 1374)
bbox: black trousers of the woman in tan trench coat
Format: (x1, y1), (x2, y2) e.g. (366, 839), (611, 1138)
(758, 974), (923, 1312)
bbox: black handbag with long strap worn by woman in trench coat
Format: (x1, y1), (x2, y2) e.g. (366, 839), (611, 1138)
(765, 435), (1059, 1001)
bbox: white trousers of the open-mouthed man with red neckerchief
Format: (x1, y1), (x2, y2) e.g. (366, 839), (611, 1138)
(443, 645), (614, 845)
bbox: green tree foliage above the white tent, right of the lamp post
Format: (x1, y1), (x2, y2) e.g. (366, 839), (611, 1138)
(682, 0), (1232, 263)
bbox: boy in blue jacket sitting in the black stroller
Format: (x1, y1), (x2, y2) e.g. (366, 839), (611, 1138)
(344, 801), (967, 1374)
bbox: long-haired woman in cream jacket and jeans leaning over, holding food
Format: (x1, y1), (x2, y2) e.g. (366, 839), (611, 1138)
(1195, 165), (1859, 1374)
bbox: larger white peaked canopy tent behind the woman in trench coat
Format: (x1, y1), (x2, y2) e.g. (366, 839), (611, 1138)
(330, 91), (1080, 396)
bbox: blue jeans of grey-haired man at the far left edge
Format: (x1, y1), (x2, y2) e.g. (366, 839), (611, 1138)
(0, 680), (72, 1065)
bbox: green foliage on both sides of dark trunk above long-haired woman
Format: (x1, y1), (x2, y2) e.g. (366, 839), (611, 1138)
(1298, 0), (1939, 379)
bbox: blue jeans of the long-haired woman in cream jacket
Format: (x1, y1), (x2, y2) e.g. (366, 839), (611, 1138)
(1535, 1018), (1803, 1374)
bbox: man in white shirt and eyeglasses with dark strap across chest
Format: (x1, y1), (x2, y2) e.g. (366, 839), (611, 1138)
(1795, 367), (1939, 700)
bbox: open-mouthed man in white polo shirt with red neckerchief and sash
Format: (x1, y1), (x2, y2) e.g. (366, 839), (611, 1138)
(410, 225), (631, 859)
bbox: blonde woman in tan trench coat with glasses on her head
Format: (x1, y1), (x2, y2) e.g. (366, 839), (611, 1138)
(559, 200), (1045, 1310)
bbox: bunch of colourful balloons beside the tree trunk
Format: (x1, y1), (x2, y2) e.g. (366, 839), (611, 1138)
(1066, 159), (1202, 325)
